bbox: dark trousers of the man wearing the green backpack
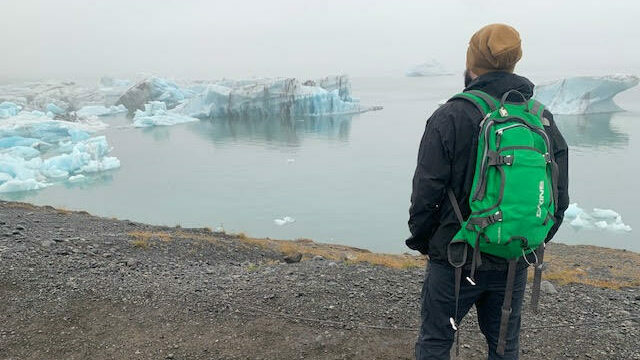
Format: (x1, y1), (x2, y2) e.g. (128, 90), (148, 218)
(416, 262), (527, 360)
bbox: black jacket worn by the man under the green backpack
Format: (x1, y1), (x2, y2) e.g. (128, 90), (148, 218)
(406, 72), (569, 270)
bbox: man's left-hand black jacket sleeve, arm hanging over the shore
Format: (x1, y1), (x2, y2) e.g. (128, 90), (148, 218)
(406, 106), (453, 254)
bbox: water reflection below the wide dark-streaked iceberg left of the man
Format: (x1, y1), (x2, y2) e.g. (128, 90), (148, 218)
(188, 115), (357, 146)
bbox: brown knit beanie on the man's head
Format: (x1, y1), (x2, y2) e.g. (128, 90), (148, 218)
(467, 24), (522, 76)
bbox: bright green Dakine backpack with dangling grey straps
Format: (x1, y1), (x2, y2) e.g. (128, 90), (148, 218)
(447, 90), (558, 354)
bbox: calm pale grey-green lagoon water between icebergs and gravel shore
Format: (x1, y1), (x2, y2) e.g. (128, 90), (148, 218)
(3, 76), (640, 252)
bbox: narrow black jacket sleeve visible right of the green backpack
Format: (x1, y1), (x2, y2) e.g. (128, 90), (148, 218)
(544, 110), (569, 242)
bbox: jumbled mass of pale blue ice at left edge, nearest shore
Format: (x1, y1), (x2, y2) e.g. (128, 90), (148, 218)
(0, 111), (120, 192)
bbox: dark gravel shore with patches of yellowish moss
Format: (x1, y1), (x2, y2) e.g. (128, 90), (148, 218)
(0, 202), (640, 360)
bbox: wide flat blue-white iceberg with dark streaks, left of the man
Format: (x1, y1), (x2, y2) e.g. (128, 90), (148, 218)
(176, 75), (381, 119)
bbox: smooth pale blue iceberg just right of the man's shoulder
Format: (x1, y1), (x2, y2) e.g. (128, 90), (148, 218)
(534, 75), (640, 115)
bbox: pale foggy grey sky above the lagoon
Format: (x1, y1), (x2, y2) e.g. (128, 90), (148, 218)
(0, 0), (640, 79)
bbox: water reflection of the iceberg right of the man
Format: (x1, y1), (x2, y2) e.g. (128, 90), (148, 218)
(554, 113), (629, 148)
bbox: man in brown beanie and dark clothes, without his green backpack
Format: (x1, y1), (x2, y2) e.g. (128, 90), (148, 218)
(406, 24), (569, 360)
